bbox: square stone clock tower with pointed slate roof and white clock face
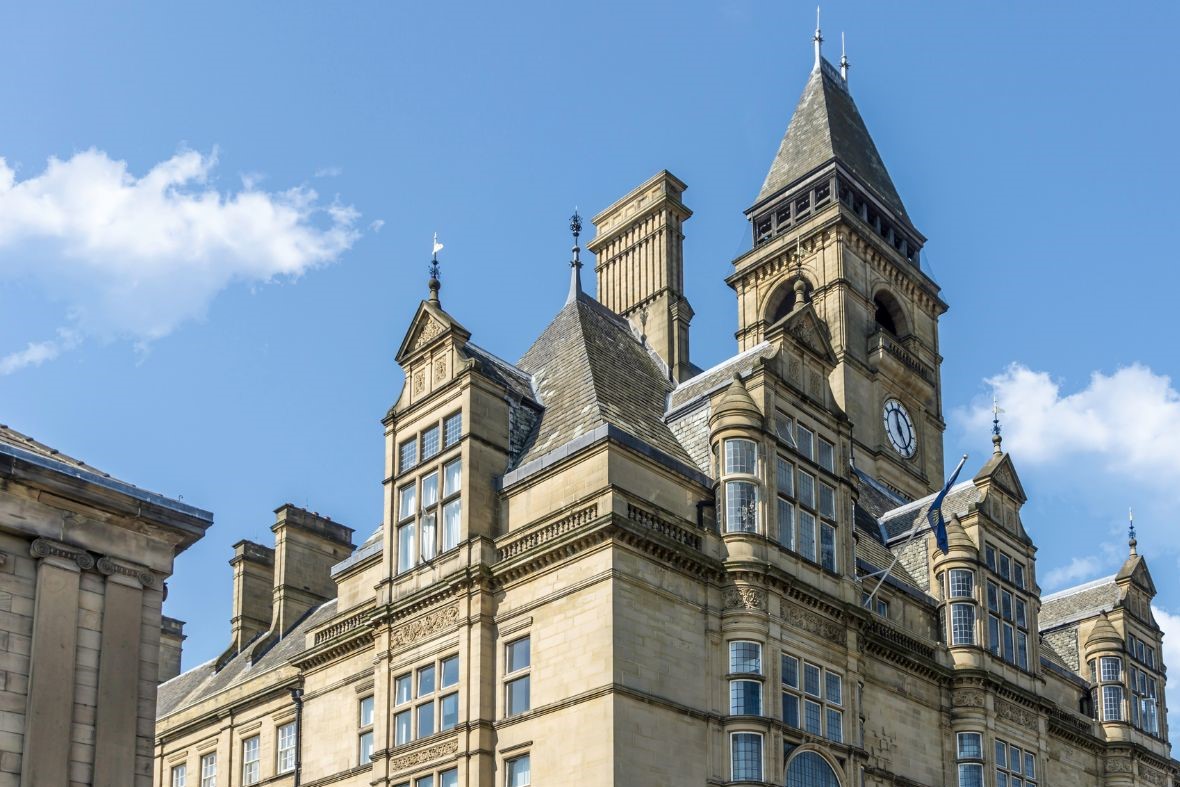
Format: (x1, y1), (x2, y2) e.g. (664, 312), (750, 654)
(726, 29), (946, 499)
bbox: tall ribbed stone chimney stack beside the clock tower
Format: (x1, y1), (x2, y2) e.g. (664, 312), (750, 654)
(586, 170), (693, 382)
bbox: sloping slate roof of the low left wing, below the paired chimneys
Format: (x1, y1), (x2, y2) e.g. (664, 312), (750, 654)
(156, 598), (336, 719)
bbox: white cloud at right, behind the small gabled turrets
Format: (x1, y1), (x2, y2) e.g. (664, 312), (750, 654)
(959, 363), (1180, 496)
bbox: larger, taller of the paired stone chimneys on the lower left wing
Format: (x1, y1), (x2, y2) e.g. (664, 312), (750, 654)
(270, 503), (355, 636)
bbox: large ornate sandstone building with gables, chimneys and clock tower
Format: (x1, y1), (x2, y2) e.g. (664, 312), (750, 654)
(156, 27), (1180, 787)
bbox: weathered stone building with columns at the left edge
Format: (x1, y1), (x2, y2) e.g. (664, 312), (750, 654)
(0, 425), (212, 787)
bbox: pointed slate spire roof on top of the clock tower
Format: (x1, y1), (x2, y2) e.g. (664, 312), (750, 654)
(756, 59), (909, 221)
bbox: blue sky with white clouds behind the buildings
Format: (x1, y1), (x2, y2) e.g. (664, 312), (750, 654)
(0, 0), (1180, 740)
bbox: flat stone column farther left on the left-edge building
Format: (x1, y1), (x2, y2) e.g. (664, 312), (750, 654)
(20, 538), (94, 787)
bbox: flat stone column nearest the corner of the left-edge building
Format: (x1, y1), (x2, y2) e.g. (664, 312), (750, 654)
(93, 557), (155, 787)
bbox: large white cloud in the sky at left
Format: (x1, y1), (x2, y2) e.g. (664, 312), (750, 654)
(0, 149), (359, 373)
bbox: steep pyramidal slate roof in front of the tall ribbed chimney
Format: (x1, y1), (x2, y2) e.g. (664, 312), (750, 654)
(517, 291), (695, 467)
